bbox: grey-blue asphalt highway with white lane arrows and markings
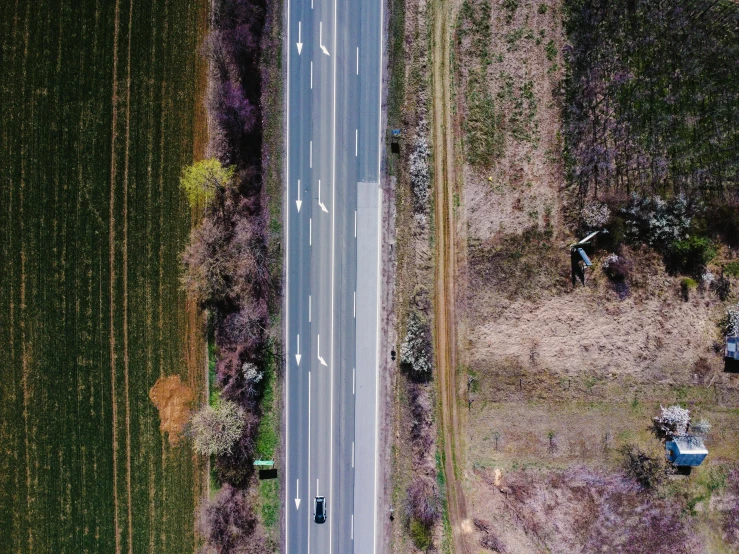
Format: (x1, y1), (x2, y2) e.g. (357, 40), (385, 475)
(284, 0), (383, 554)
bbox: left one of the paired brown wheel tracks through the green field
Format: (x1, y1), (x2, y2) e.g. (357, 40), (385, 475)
(108, 0), (121, 544)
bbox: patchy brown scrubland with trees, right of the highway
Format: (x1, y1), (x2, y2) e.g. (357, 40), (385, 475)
(388, 0), (739, 553)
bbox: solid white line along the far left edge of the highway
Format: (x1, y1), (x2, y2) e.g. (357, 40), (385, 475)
(285, 0), (290, 552)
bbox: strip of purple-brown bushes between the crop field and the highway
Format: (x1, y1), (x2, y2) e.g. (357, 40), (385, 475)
(192, 0), (279, 544)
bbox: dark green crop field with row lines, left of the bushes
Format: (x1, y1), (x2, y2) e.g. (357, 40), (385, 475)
(0, 0), (208, 554)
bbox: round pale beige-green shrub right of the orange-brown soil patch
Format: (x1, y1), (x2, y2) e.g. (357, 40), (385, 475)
(191, 400), (244, 456)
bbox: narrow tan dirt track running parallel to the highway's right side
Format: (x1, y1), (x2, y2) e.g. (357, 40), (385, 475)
(431, 0), (469, 554)
